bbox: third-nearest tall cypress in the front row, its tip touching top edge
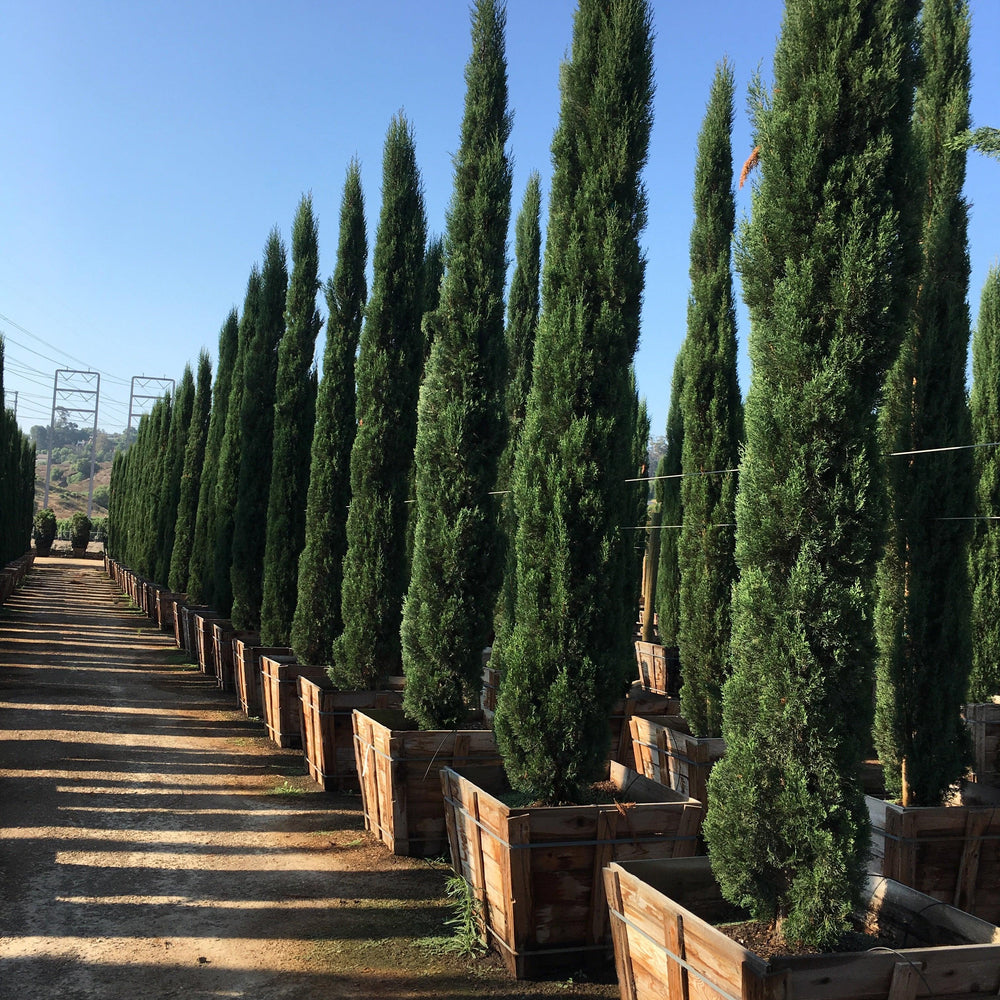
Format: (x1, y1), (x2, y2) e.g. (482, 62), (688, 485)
(402, 0), (511, 729)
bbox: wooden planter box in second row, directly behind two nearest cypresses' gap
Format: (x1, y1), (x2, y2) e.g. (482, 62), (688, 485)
(629, 715), (726, 804)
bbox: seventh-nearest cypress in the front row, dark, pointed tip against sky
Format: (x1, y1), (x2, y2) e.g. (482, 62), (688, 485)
(229, 229), (288, 631)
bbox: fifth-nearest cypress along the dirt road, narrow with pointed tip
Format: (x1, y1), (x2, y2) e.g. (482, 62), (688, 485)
(292, 160), (368, 664)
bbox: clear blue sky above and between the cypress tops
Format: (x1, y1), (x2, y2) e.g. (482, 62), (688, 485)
(0, 0), (1000, 442)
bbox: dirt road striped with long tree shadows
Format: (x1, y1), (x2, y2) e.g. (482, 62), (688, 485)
(0, 558), (618, 1000)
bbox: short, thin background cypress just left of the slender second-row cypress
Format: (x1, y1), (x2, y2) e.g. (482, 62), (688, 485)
(656, 343), (684, 647)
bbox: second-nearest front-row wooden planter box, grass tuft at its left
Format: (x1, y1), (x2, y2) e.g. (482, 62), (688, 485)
(441, 763), (702, 978)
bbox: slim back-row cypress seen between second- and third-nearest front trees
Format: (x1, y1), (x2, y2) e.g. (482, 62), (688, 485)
(494, 171), (542, 635)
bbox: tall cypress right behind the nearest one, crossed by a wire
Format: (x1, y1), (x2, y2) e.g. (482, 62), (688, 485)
(875, 0), (975, 806)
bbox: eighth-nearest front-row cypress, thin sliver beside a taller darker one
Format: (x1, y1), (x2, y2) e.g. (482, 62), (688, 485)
(212, 264), (262, 615)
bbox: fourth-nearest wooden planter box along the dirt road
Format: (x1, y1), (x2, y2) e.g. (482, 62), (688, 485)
(298, 670), (403, 792)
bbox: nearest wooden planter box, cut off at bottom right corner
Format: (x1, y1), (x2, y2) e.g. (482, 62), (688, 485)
(604, 858), (1000, 1000)
